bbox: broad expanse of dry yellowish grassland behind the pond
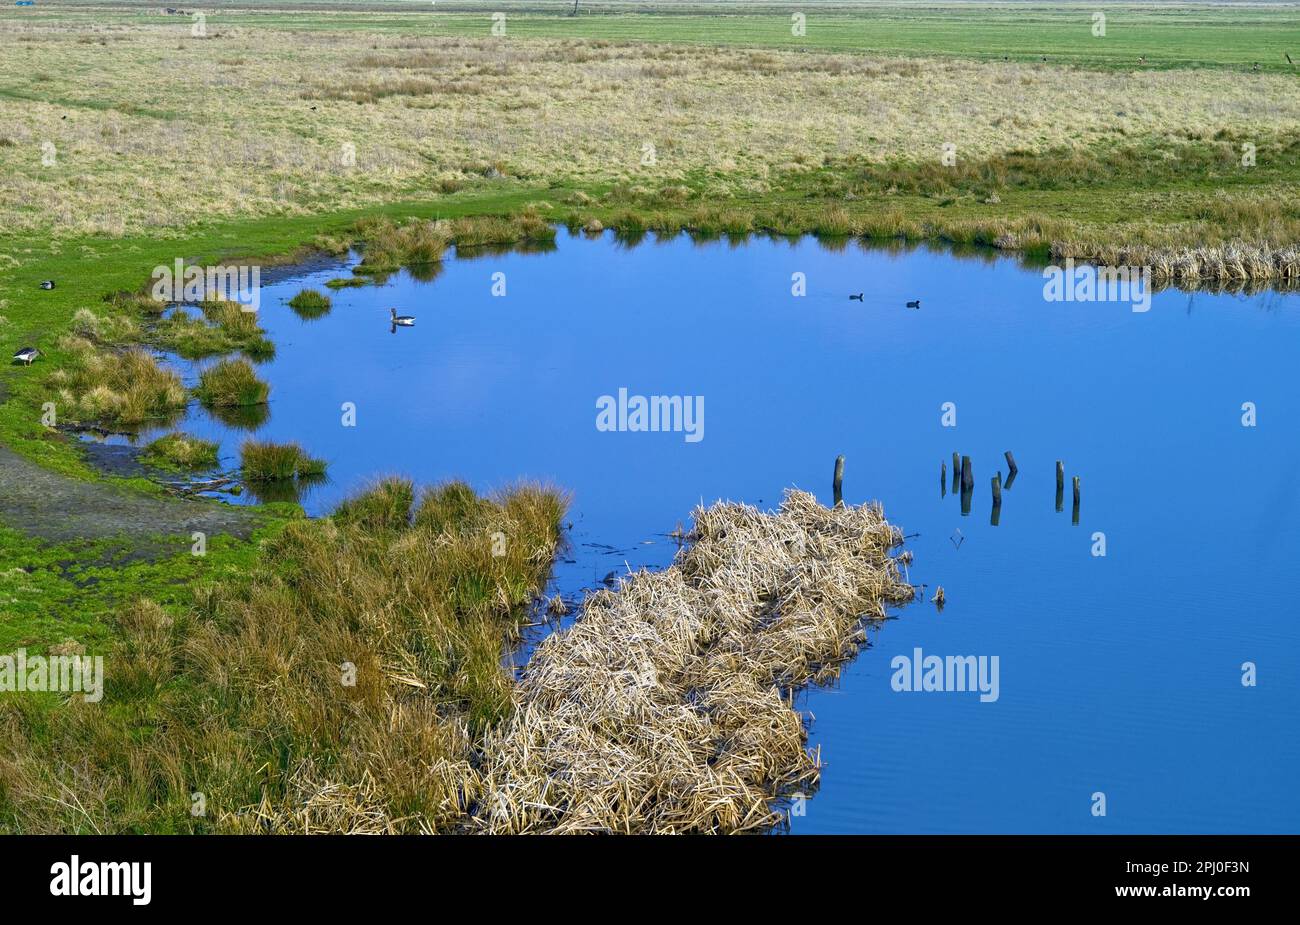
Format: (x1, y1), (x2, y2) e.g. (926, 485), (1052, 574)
(0, 19), (1300, 235)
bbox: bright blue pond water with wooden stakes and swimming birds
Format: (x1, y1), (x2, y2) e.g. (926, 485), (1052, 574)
(109, 233), (1300, 833)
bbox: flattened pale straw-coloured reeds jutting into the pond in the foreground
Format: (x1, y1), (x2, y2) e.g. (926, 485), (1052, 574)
(473, 491), (913, 833)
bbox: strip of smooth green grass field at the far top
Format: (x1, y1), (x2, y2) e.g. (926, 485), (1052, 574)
(20, 0), (1300, 74)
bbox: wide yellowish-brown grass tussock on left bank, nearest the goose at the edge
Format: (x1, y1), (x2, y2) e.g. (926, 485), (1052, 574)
(47, 336), (186, 425)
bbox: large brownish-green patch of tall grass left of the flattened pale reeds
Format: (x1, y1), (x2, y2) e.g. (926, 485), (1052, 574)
(0, 483), (564, 833)
